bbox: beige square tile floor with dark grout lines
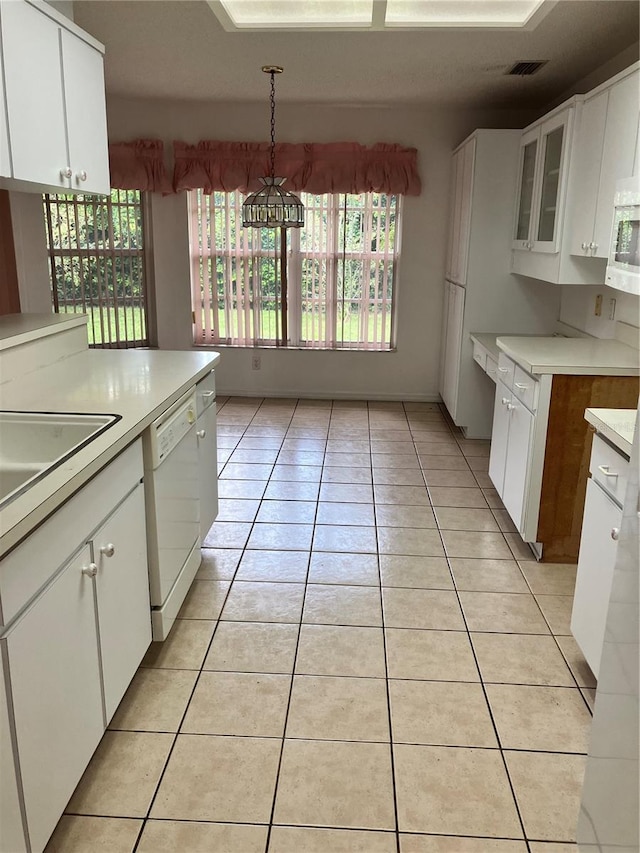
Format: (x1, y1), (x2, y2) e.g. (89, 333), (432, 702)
(47, 398), (595, 853)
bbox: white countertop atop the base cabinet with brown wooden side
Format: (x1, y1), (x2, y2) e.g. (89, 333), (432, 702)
(496, 336), (640, 376)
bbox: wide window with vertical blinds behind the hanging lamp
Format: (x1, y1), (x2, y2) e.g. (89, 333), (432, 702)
(188, 190), (400, 350)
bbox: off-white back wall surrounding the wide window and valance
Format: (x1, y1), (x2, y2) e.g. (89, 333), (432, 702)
(107, 97), (531, 400)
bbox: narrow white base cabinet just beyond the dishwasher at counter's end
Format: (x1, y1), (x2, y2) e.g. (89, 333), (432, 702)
(196, 370), (218, 542)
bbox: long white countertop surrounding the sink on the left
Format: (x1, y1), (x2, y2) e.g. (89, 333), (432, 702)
(0, 348), (220, 556)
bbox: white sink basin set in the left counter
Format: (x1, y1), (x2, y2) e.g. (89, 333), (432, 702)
(0, 411), (120, 509)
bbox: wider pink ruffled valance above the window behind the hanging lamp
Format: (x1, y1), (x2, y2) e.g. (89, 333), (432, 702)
(173, 140), (421, 195)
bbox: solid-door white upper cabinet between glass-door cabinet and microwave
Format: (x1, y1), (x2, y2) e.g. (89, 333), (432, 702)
(570, 66), (640, 258)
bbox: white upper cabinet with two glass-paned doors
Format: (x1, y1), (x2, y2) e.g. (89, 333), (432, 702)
(513, 106), (574, 253)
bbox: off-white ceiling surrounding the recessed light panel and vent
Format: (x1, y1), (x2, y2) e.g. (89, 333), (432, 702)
(73, 0), (640, 109)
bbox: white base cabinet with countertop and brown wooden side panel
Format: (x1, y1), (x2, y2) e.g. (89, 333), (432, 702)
(482, 336), (640, 563)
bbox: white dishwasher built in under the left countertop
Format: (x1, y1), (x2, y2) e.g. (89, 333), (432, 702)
(143, 389), (200, 640)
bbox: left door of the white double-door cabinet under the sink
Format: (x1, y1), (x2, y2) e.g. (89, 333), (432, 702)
(3, 545), (104, 853)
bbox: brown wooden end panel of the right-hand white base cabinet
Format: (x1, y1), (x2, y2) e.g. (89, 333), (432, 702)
(537, 375), (640, 563)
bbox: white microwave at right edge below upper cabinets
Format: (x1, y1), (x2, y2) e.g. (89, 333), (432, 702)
(605, 178), (640, 294)
